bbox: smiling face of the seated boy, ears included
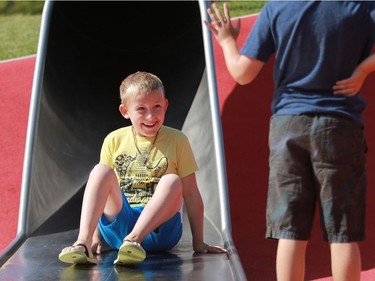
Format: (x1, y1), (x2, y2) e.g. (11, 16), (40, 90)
(120, 91), (168, 137)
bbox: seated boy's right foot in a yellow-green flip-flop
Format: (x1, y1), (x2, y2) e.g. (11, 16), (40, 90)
(114, 240), (146, 265)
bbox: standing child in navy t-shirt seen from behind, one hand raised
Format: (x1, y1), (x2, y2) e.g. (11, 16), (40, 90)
(205, 1), (375, 281)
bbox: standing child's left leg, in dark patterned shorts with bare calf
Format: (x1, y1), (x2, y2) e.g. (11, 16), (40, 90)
(266, 115), (316, 281)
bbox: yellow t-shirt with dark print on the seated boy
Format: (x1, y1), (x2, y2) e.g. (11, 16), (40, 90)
(100, 126), (198, 206)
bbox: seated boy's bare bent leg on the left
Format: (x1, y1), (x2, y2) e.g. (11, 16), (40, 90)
(59, 164), (123, 257)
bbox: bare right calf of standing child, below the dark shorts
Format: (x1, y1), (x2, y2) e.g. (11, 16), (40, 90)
(331, 243), (361, 281)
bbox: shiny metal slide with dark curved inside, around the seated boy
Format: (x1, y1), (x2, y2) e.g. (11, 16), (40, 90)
(0, 1), (246, 281)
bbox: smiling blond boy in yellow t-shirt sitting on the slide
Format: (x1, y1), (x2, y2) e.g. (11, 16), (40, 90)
(59, 72), (226, 265)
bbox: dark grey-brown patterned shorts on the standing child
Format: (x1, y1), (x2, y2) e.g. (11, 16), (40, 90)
(266, 115), (367, 243)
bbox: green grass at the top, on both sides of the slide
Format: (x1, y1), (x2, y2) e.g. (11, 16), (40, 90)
(0, 0), (266, 60)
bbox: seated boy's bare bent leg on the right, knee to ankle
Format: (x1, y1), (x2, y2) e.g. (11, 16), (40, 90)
(124, 174), (183, 243)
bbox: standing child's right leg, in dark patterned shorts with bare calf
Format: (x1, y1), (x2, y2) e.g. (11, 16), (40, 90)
(313, 116), (367, 281)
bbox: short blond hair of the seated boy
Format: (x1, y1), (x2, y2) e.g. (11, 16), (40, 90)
(120, 71), (165, 104)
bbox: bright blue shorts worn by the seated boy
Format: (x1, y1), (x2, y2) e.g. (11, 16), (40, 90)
(98, 194), (182, 251)
